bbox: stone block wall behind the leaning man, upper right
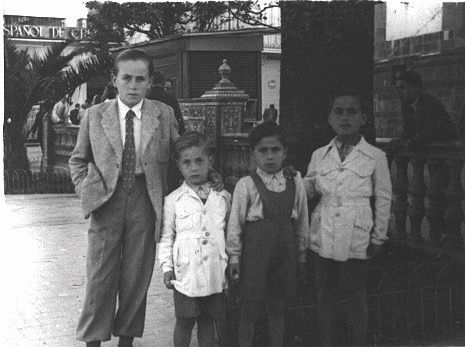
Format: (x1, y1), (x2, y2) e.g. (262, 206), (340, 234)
(374, 3), (465, 137)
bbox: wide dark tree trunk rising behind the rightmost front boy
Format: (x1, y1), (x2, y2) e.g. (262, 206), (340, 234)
(280, 1), (375, 171)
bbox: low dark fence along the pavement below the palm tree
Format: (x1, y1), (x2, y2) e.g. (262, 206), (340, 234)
(3, 170), (74, 194)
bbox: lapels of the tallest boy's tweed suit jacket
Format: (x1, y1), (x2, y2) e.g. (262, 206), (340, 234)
(101, 99), (160, 162)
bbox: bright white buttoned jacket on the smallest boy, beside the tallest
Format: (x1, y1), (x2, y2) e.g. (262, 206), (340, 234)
(158, 182), (231, 297)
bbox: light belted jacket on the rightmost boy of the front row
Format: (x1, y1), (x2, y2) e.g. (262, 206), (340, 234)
(304, 137), (392, 261)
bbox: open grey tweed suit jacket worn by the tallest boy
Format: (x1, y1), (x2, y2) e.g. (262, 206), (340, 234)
(69, 99), (179, 241)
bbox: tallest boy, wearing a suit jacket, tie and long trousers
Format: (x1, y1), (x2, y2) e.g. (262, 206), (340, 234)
(69, 49), (178, 347)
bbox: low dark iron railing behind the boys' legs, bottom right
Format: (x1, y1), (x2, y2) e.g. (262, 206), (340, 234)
(217, 245), (465, 346)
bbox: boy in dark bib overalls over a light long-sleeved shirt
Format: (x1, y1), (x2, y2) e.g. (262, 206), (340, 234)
(226, 122), (309, 347)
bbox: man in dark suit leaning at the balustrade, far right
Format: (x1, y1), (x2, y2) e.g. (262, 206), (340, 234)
(396, 71), (457, 147)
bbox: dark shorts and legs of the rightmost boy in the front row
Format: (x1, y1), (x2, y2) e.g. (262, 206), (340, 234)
(313, 253), (368, 346)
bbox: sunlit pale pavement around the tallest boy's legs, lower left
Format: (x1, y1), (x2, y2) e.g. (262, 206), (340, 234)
(0, 195), (179, 347)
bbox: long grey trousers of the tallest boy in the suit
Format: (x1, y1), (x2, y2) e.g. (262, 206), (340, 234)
(76, 177), (155, 342)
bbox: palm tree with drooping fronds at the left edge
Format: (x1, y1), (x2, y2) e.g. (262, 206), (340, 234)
(3, 40), (111, 169)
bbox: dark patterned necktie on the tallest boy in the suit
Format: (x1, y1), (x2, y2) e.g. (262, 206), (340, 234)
(122, 110), (136, 191)
